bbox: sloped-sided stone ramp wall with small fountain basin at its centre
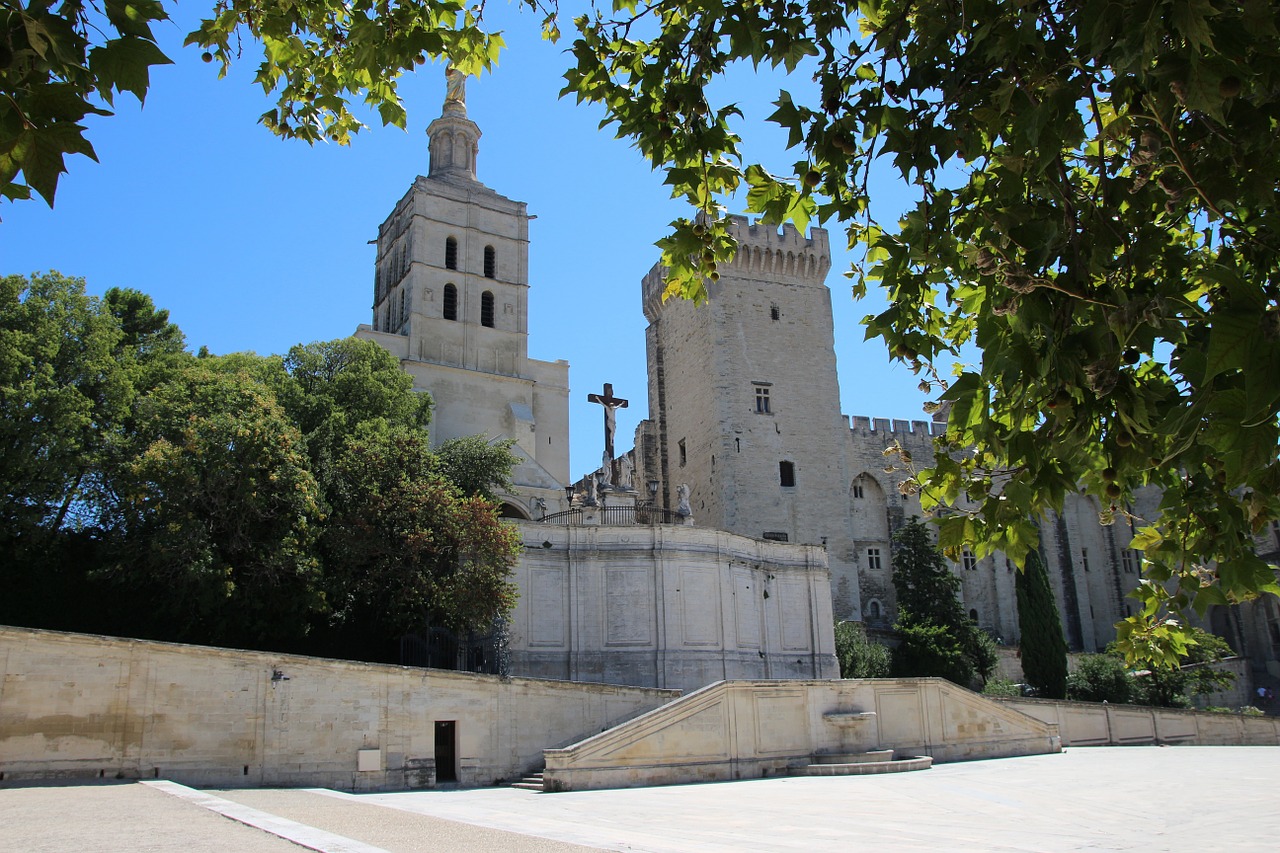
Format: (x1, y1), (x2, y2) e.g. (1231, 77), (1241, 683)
(544, 679), (1061, 790)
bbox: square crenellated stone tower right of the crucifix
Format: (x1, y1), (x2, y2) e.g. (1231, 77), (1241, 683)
(636, 216), (859, 615)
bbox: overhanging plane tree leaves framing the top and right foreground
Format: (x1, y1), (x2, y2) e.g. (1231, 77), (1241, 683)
(0, 0), (1280, 666)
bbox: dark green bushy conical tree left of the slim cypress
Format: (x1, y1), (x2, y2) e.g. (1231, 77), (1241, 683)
(892, 519), (996, 686)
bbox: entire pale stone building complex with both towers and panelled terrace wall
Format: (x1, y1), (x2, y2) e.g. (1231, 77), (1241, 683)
(357, 79), (1280, 689)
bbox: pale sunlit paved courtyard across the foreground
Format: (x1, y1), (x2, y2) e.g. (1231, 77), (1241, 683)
(0, 747), (1280, 853)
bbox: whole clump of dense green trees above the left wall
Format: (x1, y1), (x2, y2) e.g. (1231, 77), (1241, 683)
(0, 273), (520, 661)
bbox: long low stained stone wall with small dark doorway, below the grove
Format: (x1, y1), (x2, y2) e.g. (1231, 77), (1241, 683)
(0, 626), (678, 790)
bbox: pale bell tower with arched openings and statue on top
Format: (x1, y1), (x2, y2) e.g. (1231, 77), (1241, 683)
(356, 69), (568, 517)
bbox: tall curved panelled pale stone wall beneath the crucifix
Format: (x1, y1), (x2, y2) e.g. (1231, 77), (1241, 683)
(509, 523), (840, 690)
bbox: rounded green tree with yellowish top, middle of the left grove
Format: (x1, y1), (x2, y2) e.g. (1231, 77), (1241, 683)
(97, 359), (324, 646)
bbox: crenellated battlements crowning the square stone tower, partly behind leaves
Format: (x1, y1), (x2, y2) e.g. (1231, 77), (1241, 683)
(641, 215), (831, 323)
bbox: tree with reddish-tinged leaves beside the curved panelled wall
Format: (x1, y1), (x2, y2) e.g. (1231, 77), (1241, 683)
(320, 429), (520, 637)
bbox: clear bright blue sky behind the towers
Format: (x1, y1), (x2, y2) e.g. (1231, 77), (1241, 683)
(0, 0), (927, 478)
